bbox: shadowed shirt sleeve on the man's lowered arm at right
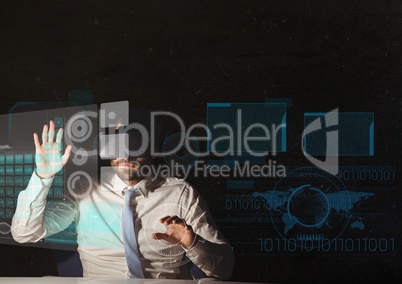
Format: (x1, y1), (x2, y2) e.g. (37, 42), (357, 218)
(182, 186), (234, 279)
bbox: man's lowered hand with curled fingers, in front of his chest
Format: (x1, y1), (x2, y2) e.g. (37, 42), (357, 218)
(152, 216), (196, 249)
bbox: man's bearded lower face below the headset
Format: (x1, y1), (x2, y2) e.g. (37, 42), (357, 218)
(111, 158), (150, 183)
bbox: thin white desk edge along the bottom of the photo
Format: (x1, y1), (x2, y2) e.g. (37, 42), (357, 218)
(0, 276), (264, 284)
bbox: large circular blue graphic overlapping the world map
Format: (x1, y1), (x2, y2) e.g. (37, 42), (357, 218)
(259, 167), (354, 246)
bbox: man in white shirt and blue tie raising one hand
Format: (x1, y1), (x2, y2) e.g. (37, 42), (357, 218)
(11, 107), (233, 279)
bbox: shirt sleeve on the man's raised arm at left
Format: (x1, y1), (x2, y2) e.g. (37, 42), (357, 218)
(11, 171), (78, 243)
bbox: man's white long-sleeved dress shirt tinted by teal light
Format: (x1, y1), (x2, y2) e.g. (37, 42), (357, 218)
(11, 171), (233, 279)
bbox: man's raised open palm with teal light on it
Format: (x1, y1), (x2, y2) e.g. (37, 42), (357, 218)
(33, 120), (71, 178)
